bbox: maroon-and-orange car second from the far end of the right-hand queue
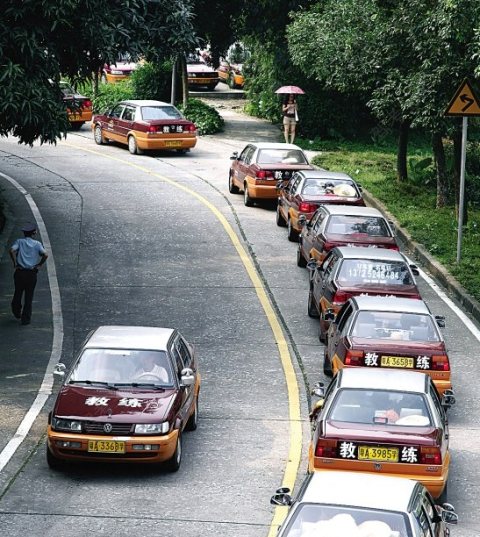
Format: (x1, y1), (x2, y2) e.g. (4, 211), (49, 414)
(277, 170), (365, 241)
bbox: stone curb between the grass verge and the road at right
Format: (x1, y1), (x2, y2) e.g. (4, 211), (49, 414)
(363, 189), (480, 323)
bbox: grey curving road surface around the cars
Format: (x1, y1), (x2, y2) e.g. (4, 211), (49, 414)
(0, 116), (480, 537)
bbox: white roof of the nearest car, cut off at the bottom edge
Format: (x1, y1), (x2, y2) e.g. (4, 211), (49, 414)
(298, 470), (419, 511)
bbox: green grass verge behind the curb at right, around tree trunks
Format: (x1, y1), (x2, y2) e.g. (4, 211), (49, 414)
(296, 139), (480, 300)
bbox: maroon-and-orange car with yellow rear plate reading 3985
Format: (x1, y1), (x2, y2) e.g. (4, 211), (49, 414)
(309, 368), (450, 503)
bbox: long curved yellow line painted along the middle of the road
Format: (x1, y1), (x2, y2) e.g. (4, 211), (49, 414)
(62, 142), (302, 537)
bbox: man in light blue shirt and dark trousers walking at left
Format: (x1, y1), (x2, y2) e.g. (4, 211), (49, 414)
(10, 224), (48, 324)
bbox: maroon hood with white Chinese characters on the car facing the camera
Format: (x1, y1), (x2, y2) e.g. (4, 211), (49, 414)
(53, 386), (177, 423)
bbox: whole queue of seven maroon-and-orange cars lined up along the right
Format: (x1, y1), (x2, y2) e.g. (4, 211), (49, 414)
(228, 143), (458, 537)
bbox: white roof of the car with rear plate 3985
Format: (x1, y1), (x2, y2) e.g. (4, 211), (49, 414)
(338, 367), (428, 393)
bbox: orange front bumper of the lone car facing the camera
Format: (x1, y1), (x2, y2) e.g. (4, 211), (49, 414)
(47, 425), (178, 463)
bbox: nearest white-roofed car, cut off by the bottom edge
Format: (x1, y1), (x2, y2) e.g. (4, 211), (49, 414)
(270, 471), (458, 537)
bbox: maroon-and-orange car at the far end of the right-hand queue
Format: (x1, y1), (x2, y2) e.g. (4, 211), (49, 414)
(228, 142), (313, 207)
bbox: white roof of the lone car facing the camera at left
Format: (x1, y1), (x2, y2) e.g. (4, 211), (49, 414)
(85, 326), (175, 350)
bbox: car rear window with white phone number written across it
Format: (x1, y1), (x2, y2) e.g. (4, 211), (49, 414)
(337, 259), (414, 287)
